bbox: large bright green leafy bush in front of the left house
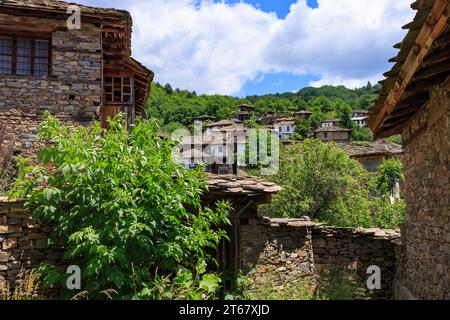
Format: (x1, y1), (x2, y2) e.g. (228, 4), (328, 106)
(9, 116), (229, 299)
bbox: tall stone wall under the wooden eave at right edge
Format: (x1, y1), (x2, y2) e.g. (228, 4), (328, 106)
(396, 81), (450, 299)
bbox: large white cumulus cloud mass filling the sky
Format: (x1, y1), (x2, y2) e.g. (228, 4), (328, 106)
(78, 0), (413, 94)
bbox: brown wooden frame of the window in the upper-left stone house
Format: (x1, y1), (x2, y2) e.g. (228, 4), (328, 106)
(0, 31), (53, 78)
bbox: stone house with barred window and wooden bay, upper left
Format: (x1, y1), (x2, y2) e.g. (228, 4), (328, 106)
(0, 0), (153, 170)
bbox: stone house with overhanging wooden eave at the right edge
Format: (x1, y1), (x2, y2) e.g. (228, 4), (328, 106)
(370, 0), (450, 299)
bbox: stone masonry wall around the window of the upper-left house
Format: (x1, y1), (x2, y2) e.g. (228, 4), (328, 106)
(0, 14), (102, 170)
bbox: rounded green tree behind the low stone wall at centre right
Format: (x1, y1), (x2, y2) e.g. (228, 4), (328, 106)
(261, 139), (372, 227)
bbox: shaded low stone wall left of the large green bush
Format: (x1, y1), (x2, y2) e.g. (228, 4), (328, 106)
(0, 198), (60, 287)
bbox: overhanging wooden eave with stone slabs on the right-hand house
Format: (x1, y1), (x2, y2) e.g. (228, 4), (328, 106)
(369, 0), (450, 138)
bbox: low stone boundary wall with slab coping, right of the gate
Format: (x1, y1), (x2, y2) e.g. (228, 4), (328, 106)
(241, 219), (400, 298)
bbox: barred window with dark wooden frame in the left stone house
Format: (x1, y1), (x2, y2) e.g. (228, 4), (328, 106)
(0, 36), (50, 77)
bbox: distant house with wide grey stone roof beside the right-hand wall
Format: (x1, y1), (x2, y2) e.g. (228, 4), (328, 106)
(339, 139), (403, 172)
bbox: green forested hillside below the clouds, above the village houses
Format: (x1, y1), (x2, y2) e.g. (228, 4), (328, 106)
(148, 83), (378, 131)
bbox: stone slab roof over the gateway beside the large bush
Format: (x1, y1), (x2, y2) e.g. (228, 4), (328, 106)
(208, 174), (281, 196)
